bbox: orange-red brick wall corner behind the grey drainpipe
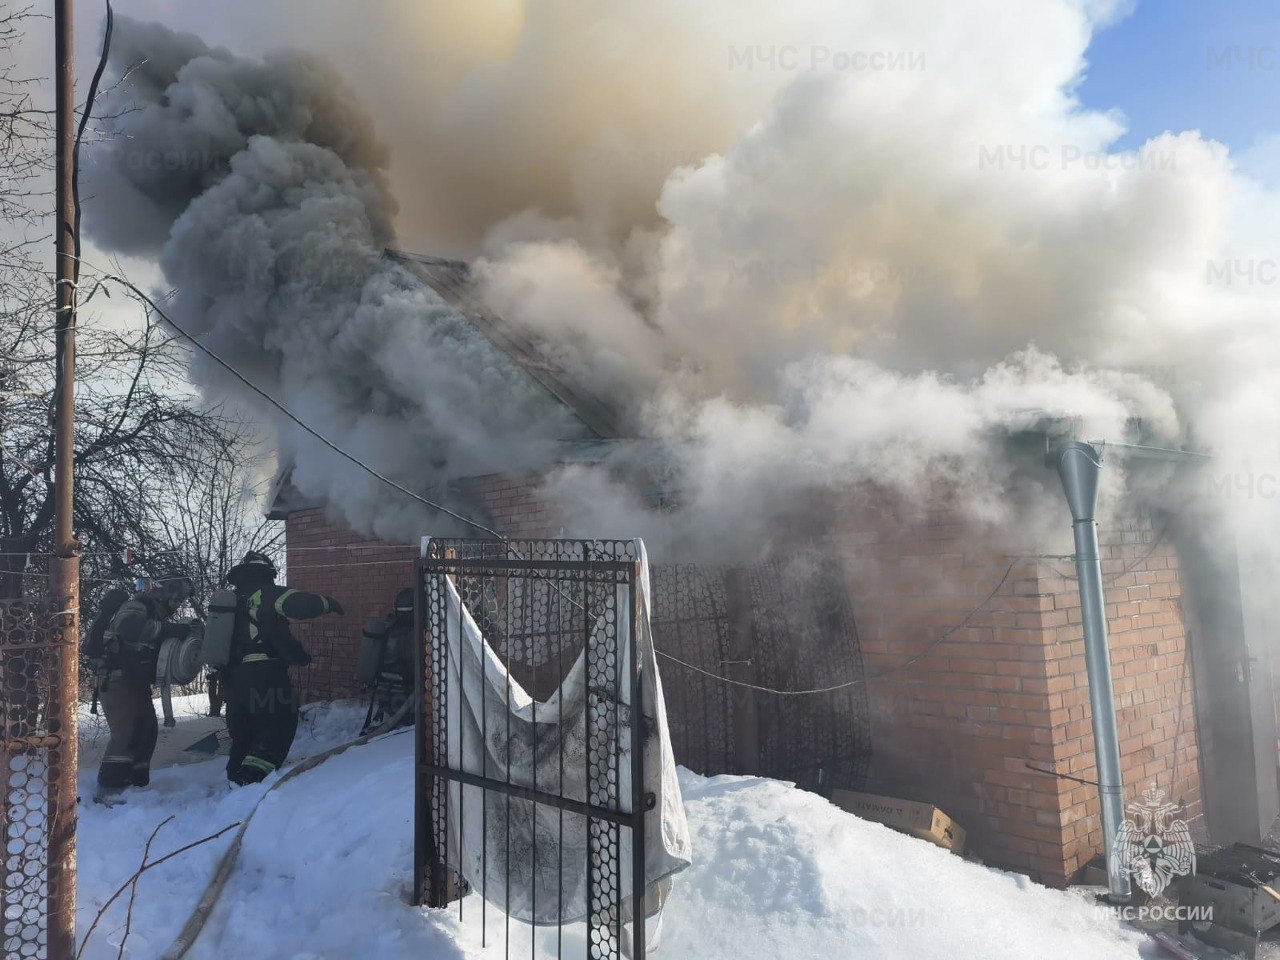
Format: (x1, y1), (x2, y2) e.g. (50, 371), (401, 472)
(833, 495), (1201, 884)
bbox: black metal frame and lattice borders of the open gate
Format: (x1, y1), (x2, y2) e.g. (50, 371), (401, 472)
(412, 538), (655, 960)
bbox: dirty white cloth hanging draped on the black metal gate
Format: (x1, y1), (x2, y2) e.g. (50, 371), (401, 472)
(445, 541), (690, 924)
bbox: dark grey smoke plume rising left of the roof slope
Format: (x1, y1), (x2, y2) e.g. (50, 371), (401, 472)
(86, 20), (581, 536)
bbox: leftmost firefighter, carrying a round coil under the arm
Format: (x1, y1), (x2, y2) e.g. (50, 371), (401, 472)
(93, 577), (193, 806)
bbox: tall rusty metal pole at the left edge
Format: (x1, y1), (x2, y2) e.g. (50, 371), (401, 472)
(45, 0), (79, 960)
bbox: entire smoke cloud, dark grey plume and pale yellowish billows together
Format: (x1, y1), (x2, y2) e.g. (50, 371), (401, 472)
(91, 0), (1280, 570)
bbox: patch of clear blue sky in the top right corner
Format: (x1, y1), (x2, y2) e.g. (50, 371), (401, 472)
(1078, 0), (1280, 152)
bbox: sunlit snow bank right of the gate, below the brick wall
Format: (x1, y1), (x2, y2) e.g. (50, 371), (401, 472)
(645, 774), (1143, 960)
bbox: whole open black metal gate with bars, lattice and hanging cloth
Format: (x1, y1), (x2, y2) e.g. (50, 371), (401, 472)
(413, 539), (653, 960)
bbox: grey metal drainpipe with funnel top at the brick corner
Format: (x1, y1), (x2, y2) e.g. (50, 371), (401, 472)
(1057, 443), (1133, 902)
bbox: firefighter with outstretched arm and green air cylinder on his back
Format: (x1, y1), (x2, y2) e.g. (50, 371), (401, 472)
(223, 550), (344, 785)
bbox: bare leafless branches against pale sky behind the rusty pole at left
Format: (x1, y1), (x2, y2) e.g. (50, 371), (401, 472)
(0, 5), (280, 605)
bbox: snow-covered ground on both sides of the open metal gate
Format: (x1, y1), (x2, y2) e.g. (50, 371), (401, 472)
(79, 704), (1156, 960)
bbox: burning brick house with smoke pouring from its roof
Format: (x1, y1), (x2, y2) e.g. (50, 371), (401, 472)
(264, 253), (1277, 884)
